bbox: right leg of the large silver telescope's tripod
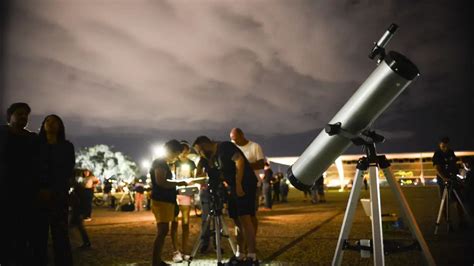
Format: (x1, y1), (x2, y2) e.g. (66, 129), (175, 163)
(382, 167), (436, 265)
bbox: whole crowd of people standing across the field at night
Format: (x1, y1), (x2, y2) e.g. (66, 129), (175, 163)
(0, 103), (474, 265)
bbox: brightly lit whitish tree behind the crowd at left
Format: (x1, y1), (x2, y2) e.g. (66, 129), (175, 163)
(76, 144), (138, 181)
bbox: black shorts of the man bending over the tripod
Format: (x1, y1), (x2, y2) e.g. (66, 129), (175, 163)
(228, 187), (257, 219)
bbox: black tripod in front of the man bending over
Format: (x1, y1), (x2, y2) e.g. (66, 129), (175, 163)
(188, 185), (236, 265)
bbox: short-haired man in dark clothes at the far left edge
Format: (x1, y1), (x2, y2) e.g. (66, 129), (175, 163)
(0, 102), (39, 265)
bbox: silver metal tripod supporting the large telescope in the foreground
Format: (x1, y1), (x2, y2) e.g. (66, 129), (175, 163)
(332, 142), (435, 266)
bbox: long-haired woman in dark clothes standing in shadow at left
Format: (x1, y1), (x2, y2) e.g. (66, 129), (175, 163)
(37, 115), (75, 265)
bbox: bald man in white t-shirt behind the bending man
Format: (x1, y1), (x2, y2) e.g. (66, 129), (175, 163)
(230, 128), (265, 256)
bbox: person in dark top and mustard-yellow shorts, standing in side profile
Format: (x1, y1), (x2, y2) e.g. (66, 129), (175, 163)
(150, 140), (186, 266)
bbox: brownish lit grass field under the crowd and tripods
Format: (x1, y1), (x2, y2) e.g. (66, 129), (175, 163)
(71, 187), (474, 265)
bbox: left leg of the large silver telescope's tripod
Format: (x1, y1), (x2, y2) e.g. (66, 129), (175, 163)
(332, 166), (364, 266)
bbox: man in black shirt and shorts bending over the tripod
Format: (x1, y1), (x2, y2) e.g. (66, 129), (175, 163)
(193, 136), (259, 265)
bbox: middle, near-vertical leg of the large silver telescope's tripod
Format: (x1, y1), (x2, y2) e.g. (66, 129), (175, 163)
(369, 166), (385, 265)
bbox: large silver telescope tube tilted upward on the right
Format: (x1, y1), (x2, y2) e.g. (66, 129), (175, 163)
(288, 51), (419, 190)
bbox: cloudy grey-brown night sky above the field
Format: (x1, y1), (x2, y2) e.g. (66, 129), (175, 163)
(1, 0), (474, 159)
